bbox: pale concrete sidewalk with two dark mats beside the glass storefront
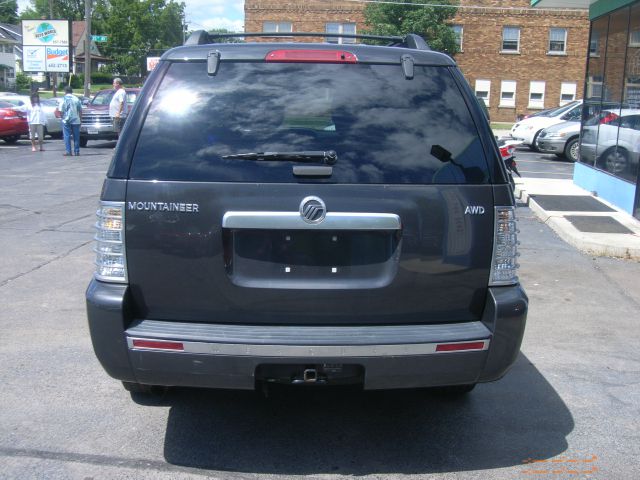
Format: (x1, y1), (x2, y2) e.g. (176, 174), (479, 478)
(515, 178), (640, 261)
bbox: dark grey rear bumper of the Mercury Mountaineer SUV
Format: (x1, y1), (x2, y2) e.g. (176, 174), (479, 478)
(87, 280), (527, 389)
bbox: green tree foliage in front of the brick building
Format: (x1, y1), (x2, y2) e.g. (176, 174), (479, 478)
(364, 0), (458, 54)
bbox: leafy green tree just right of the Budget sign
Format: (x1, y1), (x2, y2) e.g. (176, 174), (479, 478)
(93, 0), (184, 75)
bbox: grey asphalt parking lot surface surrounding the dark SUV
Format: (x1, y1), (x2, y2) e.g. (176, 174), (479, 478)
(0, 140), (640, 479)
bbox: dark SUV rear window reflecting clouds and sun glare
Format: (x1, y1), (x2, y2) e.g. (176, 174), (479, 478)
(130, 62), (489, 184)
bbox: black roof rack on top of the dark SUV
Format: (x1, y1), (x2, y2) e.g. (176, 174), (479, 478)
(184, 30), (431, 50)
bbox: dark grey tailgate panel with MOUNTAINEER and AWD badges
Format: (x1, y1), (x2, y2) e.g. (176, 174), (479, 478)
(126, 180), (493, 325)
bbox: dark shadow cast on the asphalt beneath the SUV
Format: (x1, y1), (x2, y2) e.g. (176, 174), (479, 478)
(156, 354), (574, 475)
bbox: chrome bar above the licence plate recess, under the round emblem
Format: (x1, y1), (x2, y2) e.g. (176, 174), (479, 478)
(222, 212), (401, 230)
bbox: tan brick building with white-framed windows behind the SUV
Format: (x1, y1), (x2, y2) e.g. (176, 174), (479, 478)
(244, 0), (589, 122)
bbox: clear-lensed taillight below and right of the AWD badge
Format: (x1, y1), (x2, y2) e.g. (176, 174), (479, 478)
(489, 207), (519, 286)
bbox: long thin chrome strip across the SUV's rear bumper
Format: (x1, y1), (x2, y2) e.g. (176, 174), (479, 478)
(127, 337), (490, 358)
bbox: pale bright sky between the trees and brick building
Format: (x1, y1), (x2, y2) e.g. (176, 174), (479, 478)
(18, 0), (244, 34)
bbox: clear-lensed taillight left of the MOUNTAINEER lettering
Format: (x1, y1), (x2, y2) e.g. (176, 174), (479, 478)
(94, 202), (127, 282)
